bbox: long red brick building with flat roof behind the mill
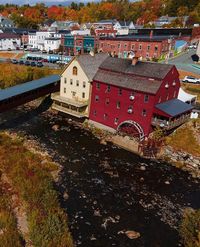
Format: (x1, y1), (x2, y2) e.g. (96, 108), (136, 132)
(98, 35), (174, 60)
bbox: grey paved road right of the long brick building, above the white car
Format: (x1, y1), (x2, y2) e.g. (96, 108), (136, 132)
(168, 49), (200, 75)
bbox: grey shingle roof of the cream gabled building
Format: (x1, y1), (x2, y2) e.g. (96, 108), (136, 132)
(77, 53), (108, 81)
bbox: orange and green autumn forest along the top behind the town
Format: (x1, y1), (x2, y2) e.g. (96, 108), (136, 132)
(0, 0), (200, 29)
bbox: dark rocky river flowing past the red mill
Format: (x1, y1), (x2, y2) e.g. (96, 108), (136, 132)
(0, 103), (200, 247)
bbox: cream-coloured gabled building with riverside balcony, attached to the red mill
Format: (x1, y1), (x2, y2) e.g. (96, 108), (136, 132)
(52, 53), (108, 118)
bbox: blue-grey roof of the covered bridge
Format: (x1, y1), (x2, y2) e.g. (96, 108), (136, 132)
(0, 75), (60, 101)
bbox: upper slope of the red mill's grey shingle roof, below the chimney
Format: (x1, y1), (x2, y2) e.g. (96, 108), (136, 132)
(100, 57), (173, 79)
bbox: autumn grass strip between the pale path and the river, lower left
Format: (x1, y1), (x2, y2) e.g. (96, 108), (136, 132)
(0, 133), (73, 247)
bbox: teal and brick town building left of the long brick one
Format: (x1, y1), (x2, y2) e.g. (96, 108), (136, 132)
(62, 35), (98, 55)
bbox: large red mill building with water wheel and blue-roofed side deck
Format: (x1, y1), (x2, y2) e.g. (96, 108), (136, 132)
(89, 57), (192, 139)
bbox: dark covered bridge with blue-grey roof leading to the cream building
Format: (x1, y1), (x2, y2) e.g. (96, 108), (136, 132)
(0, 75), (60, 113)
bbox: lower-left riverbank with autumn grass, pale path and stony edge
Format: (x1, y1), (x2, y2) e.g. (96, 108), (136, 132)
(0, 132), (73, 247)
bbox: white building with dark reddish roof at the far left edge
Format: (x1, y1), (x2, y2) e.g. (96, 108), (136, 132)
(0, 33), (21, 51)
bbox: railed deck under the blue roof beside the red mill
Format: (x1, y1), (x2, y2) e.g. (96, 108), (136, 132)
(151, 114), (190, 130)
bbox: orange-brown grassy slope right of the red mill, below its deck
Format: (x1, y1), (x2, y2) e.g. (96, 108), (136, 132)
(167, 121), (200, 156)
